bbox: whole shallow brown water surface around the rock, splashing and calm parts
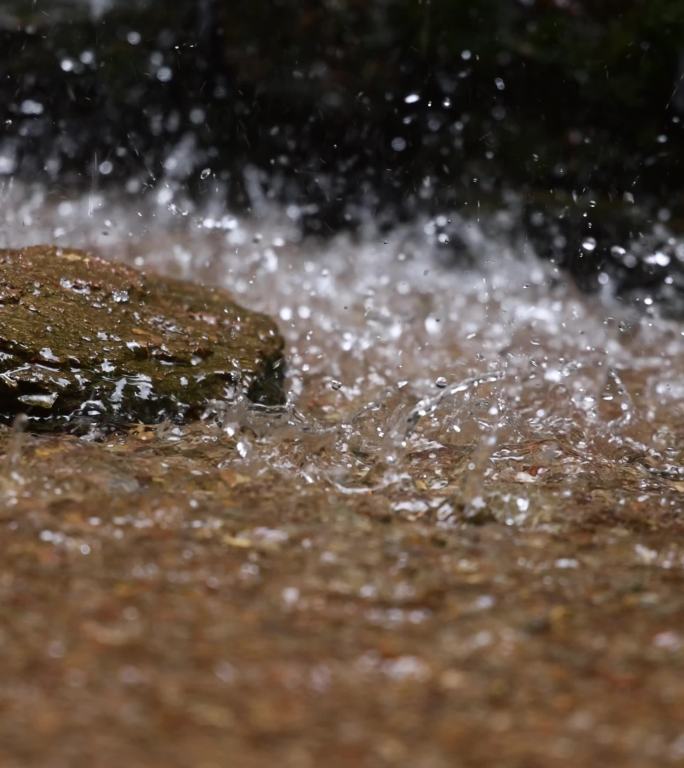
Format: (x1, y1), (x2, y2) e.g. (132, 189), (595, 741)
(0, 187), (684, 768)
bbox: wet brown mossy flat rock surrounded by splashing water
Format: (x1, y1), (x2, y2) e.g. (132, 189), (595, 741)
(0, 246), (284, 429)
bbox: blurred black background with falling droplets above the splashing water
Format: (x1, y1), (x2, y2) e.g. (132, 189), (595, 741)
(0, 0), (684, 313)
